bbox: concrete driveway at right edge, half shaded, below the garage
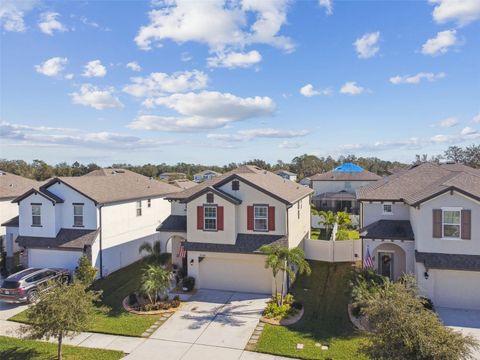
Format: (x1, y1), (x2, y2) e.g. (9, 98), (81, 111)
(437, 308), (480, 360)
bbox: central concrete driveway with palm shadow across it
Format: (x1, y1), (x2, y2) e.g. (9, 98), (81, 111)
(127, 289), (275, 360)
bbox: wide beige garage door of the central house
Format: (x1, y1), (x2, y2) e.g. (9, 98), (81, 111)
(199, 255), (274, 294)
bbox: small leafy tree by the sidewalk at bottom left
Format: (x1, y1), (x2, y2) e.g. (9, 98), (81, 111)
(23, 281), (100, 360)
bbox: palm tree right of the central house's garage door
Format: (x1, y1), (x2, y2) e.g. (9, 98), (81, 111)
(260, 245), (312, 306)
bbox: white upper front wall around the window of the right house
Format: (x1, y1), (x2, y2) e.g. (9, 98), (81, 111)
(410, 193), (480, 255)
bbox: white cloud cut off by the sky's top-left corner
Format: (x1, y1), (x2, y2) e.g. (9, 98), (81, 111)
(0, 0), (38, 32)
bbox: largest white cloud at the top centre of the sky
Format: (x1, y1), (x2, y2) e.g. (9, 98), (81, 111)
(135, 0), (294, 52)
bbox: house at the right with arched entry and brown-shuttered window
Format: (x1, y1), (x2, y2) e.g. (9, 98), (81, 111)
(357, 163), (480, 310)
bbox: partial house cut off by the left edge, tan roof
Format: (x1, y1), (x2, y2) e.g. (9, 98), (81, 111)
(0, 170), (40, 266)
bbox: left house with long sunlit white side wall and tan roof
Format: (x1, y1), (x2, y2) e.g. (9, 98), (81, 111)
(3, 169), (180, 276)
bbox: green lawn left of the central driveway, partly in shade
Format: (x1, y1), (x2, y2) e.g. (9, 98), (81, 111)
(9, 261), (160, 336)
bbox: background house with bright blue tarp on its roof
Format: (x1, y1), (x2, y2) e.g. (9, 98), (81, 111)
(310, 163), (381, 214)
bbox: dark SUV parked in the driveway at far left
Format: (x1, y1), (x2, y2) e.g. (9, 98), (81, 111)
(0, 268), (70, 303)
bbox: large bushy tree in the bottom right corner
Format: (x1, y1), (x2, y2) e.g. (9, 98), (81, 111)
(361, 279), (478, 360)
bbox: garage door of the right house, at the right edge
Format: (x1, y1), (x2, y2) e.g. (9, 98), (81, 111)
(434, 270), (480, 310)
